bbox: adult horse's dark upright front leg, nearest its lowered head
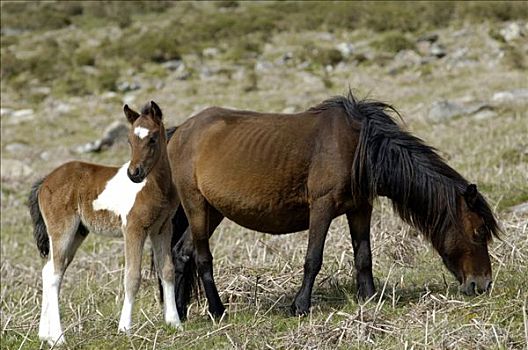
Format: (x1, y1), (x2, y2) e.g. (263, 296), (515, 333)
(346, 203), (376, 299)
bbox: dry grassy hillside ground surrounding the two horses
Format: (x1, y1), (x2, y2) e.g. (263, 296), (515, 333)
(0, 1), (528, 349)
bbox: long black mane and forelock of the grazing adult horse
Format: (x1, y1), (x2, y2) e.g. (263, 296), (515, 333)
(312, 91), (500, 249)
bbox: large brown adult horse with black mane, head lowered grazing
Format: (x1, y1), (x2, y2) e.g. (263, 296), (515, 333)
(168, 93), (499, 316)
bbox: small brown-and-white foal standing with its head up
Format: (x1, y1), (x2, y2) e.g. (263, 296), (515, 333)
(29, 102), (180, 344)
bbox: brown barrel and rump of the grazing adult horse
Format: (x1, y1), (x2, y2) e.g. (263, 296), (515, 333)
(169, 107), (360, 233)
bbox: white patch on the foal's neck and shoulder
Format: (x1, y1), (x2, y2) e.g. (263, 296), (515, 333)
(92, 162), (147, 226)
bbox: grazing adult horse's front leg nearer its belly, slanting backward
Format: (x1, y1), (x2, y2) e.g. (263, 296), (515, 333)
(291, 199), (333, 316)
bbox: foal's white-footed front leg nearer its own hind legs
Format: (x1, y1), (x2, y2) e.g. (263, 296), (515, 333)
(118, 227), (146, 332)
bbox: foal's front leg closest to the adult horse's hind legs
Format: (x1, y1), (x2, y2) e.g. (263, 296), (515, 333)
(150, 218), (181, 327)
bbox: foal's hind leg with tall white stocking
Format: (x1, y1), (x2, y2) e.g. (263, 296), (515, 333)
(39, 218), (86, 345)
